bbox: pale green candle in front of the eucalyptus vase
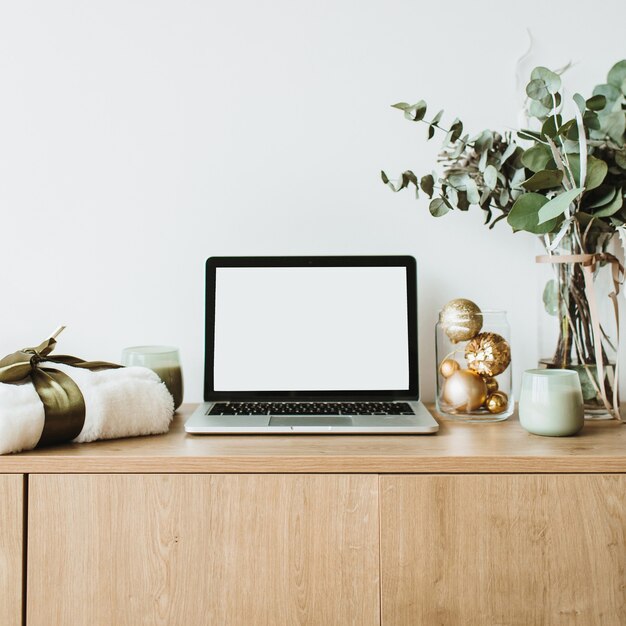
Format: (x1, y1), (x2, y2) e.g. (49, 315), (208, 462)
(519, 369), (584, 437)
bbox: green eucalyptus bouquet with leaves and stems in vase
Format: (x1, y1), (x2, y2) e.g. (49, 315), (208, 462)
(381, 60), (626, 417)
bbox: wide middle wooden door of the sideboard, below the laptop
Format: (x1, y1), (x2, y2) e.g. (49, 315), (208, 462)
(28, 475), (380, 626)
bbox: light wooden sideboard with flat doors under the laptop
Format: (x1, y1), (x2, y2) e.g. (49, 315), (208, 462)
(0, 406), (626, 626)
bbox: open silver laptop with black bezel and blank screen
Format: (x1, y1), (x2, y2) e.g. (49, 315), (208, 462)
(185, 256), (439, 434)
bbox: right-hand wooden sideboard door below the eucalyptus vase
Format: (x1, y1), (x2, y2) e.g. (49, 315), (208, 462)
(380, 475), (626, 626)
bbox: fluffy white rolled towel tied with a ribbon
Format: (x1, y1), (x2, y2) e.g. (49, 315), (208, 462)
(0, 363), (174, 454)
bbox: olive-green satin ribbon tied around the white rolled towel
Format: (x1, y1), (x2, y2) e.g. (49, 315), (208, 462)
(0, 337), (122, 447)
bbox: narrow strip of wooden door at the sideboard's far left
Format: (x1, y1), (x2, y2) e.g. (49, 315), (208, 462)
(0, 475), (24, 626)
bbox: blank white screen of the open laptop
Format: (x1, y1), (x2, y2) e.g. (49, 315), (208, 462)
(214, 267), (409, 391)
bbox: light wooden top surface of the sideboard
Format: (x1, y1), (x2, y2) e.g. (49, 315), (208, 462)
(0, 405), (626, 473)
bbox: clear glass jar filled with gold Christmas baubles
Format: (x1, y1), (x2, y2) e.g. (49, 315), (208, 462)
(435, 311), (514, 422)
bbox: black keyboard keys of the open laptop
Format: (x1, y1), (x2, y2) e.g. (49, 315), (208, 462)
(208, 402), (415, 415)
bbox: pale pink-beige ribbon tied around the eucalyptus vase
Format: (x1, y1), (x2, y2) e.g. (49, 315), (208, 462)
(536, 252), (624, 421)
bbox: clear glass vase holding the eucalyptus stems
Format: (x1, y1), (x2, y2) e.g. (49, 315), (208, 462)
(539, 233), (618, 419)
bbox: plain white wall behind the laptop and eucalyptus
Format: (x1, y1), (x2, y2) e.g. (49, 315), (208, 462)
(0, 0), (626, 401)
